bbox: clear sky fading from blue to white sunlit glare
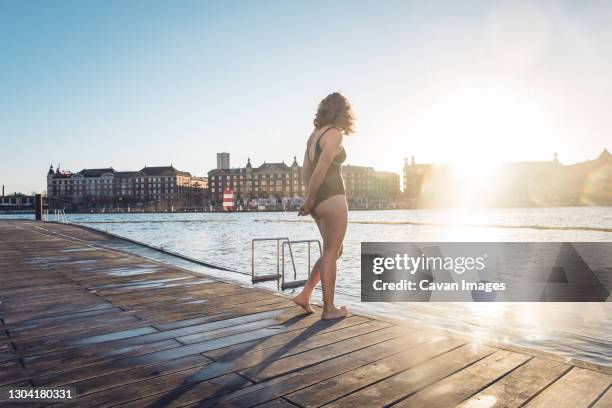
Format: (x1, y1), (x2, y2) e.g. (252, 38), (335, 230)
(0, 0), (612, 193)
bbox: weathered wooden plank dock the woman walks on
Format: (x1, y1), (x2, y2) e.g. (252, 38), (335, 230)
(0, 221), (612, 408)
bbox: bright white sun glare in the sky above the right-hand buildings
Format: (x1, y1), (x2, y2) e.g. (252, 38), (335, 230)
(418, 81), (558, 168)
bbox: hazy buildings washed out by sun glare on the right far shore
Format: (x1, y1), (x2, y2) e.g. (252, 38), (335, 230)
(403, 149), (612, 208)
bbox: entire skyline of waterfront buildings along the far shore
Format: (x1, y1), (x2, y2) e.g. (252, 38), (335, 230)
(26, 149), (612, 212)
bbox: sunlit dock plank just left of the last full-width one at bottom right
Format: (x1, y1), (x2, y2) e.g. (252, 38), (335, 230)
(457, 357), (572, 408)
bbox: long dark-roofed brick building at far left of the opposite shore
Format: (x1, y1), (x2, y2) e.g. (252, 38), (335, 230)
(47, 165), (208, 209)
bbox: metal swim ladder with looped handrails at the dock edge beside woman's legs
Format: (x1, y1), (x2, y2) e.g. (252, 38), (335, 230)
(251, 237), (323, 290)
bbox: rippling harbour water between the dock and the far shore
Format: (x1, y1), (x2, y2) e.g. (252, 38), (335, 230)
(5, 207), (612, 366)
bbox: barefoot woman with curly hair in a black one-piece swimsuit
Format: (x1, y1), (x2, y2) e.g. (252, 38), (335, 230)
(293, 92), (355, 320)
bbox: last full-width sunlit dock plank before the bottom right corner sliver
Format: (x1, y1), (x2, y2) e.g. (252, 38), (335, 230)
(525, 367), (612, 408)
